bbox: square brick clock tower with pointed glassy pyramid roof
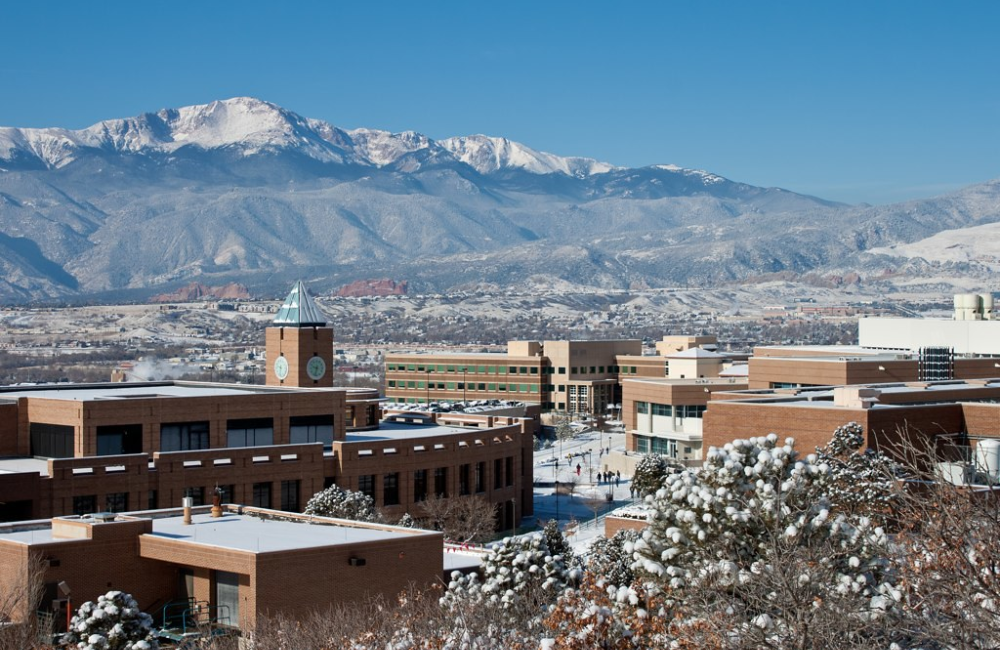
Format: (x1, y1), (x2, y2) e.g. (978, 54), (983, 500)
(266, 280), (333, 388)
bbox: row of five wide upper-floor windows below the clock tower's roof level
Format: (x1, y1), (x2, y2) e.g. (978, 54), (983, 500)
(29, 415), (333, 458)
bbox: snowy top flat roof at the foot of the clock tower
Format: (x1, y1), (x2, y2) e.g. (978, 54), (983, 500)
(0, 382), (337, 402)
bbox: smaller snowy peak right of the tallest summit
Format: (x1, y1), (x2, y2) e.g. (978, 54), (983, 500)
(438, 135), (616, 177)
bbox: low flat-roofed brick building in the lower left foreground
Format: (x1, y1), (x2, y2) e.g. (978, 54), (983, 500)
(0, 506), (444, 632)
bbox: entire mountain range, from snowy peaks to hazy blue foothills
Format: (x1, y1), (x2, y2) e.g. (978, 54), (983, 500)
(0, 97), (1000, 302)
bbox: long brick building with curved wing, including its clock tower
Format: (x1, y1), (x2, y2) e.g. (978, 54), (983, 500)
(0, 284), (537, 528)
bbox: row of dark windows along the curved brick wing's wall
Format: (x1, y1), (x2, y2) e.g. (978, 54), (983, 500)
(358, 456), (514, 506)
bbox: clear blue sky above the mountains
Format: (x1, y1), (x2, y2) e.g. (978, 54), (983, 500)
(0, 0), (1000, 203)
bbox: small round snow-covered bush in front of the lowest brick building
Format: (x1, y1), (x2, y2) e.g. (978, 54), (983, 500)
(63, 591), (159, 650)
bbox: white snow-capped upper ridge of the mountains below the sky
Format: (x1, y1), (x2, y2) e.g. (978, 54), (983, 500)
(0, 97), (614, 176)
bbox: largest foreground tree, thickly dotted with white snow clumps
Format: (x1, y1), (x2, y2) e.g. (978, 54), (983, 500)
(633, 434), (900, 647)
